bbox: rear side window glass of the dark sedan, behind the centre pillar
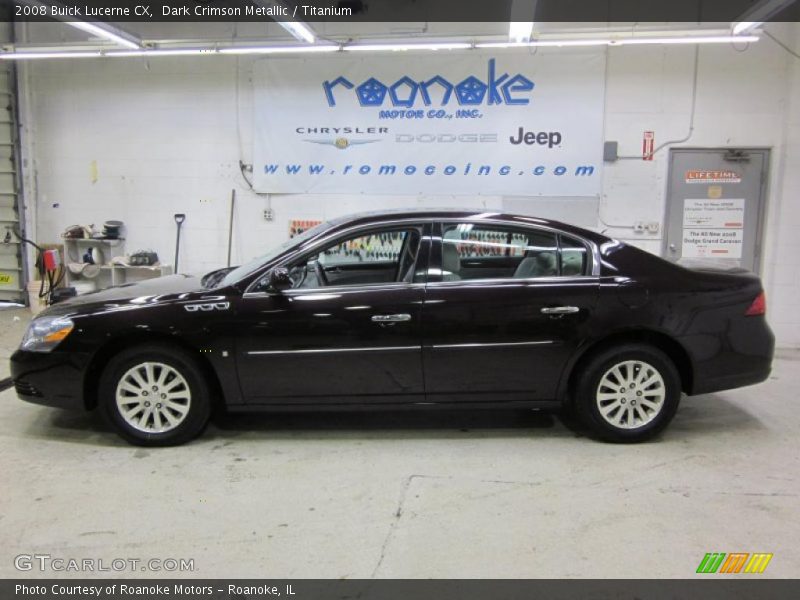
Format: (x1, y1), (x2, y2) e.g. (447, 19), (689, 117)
(442, 223), (588, 281)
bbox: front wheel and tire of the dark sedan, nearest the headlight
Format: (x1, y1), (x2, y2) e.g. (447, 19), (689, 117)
(98, 344), (211, 446)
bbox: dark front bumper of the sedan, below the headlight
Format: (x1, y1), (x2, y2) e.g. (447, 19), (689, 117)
(11, 350), (90, 410)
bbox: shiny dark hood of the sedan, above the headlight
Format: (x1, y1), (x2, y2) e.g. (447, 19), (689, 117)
(44, 275), (208, 315)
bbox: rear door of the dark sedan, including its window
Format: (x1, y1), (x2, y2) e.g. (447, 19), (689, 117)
(422, 222), (599, 402)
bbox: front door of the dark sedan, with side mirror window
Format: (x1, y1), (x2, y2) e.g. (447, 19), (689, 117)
(237, 223), (430, 405)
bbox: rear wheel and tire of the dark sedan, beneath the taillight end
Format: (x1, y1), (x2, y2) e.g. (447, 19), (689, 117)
(574, 343), (681, 443)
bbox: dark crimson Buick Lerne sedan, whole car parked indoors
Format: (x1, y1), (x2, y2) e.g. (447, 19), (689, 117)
(11, 210), (774, 445)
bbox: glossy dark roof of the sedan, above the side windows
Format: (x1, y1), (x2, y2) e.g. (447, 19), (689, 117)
(328, 208), (611, 244)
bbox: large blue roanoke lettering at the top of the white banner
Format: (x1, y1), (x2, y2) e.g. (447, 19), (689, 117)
(322, 58), (535, 108)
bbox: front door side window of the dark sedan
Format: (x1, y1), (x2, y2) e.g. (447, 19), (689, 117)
(282, 228), (421, 289)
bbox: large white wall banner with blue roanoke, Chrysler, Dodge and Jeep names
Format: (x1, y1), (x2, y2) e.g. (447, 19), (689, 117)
(253, 49), (605, 196)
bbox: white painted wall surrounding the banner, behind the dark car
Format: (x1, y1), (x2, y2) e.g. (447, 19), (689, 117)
(15, 24), (800, 346)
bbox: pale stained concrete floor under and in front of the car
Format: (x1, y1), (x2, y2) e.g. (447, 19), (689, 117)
(0, 311), (800, 578)
